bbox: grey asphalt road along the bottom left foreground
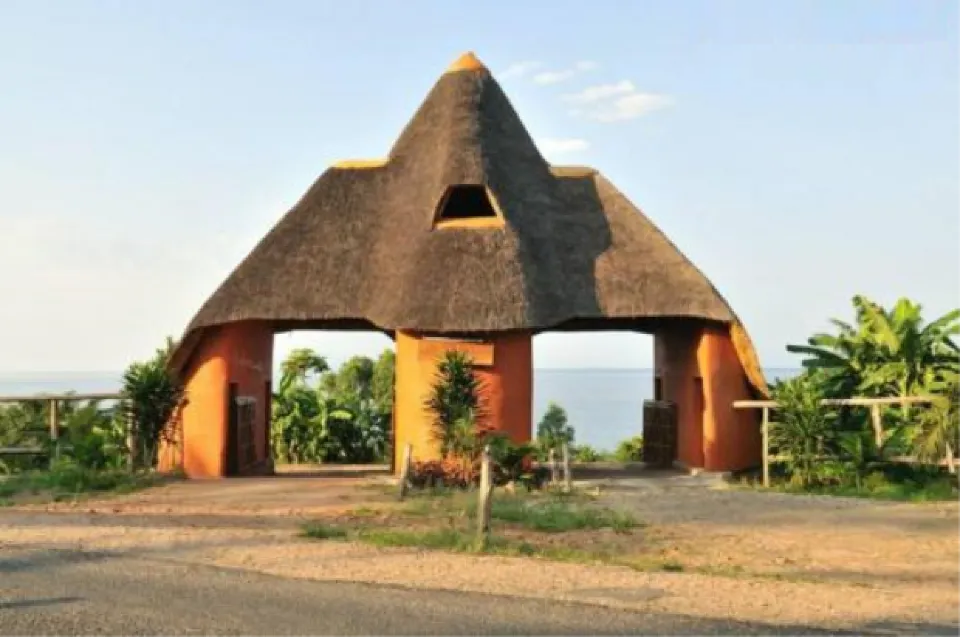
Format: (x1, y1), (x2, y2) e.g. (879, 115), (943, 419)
(0, 546), (856, 637)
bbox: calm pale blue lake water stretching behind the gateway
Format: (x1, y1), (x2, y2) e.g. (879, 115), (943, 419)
(0, 369), (798, 450)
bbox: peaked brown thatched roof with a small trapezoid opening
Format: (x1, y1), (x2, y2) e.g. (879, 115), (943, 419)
(172, 55), (768, 396)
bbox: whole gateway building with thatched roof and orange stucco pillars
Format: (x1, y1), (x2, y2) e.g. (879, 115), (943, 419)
(167, 54), (765, 476)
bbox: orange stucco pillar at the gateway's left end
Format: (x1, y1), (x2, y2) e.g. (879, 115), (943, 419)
(161, 321), (273, 478)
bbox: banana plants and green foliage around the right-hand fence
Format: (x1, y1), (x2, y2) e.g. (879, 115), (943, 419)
(771, 296), (960, 488)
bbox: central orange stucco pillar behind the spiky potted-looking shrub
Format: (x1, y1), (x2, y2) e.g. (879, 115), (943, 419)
(394, 332), (533, 469)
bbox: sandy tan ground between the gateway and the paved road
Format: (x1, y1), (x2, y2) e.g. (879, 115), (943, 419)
(0, 474), (960, 635)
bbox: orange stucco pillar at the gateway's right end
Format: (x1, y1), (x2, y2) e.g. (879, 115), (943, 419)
(654, 326), (760, 471)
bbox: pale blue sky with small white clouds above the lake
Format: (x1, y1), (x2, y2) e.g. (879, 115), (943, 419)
(0, 0), (960, 373)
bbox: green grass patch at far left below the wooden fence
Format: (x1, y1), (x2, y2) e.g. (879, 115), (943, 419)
(0, 463), (164, 502)
